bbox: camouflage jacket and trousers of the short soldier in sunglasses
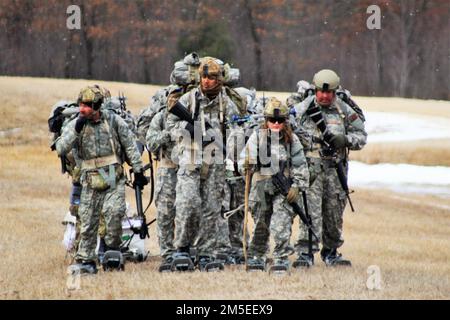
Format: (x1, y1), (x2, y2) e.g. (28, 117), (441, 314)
(239, 129), (309, 259)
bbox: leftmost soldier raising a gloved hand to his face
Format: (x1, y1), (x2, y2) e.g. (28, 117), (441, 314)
(56, 87), (148, 273)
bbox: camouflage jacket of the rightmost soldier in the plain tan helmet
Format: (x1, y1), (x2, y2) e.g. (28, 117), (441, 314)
(294, 96), (367, 159)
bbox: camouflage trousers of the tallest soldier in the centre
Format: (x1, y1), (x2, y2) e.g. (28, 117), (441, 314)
(175, 165), (225, 255)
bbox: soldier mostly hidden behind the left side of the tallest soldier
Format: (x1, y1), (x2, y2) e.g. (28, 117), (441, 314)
(139, 52), (200, 271)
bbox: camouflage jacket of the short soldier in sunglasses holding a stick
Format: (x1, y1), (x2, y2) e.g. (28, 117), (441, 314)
(238, 129), (309, 191)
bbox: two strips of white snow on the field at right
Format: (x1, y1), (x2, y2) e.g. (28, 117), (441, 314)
(349, 112), (450, 198)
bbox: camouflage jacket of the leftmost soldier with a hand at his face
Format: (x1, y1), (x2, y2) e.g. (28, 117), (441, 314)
(56, 110), (142, 172)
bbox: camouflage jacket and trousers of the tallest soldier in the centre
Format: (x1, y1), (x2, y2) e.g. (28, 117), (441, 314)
(167, 87), (244, 255)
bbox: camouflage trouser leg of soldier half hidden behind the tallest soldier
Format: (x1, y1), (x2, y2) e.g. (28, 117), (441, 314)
(155, 167), (177, 258)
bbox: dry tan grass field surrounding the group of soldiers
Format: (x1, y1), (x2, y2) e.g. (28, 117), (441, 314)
(0, 77), (450, 300)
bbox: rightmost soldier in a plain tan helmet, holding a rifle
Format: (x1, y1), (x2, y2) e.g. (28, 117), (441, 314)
(295, 70), (367, 266)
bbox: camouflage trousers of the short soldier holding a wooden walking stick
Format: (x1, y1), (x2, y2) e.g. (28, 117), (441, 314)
(249, 180), (295, 259)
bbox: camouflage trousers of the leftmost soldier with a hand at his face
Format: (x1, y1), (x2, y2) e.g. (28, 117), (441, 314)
(75, 178), (126, 261)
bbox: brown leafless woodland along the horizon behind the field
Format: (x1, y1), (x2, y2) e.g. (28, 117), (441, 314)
(0, 0), (450, 100)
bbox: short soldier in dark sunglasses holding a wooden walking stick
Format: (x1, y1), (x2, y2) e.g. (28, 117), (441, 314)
(239, 98), (309, 269)
